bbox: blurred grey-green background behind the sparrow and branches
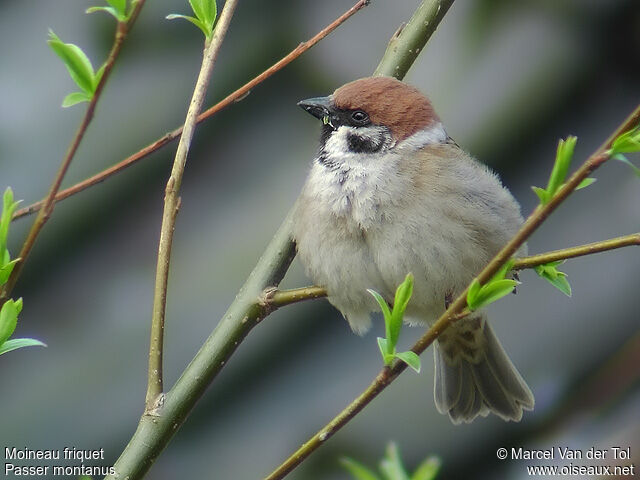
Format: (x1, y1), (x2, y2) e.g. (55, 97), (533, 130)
(0, 0), (640, 480)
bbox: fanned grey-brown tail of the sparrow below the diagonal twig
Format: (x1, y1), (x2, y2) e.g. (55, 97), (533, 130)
(434, 314), (534, 424)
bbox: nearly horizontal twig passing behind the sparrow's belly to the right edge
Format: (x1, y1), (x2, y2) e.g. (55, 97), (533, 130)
(267, 232), (640, 308)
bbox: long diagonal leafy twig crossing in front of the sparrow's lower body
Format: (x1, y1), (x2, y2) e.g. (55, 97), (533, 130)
(265, 105), (640, 480)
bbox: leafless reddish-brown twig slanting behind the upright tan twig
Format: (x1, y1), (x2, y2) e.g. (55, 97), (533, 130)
(12, 0), (369, 220)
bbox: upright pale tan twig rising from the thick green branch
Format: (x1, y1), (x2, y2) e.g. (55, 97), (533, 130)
(145, 0), (238, 414)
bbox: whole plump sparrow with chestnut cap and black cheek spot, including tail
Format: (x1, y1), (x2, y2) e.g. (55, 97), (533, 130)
(293, 77), (534, 424)
